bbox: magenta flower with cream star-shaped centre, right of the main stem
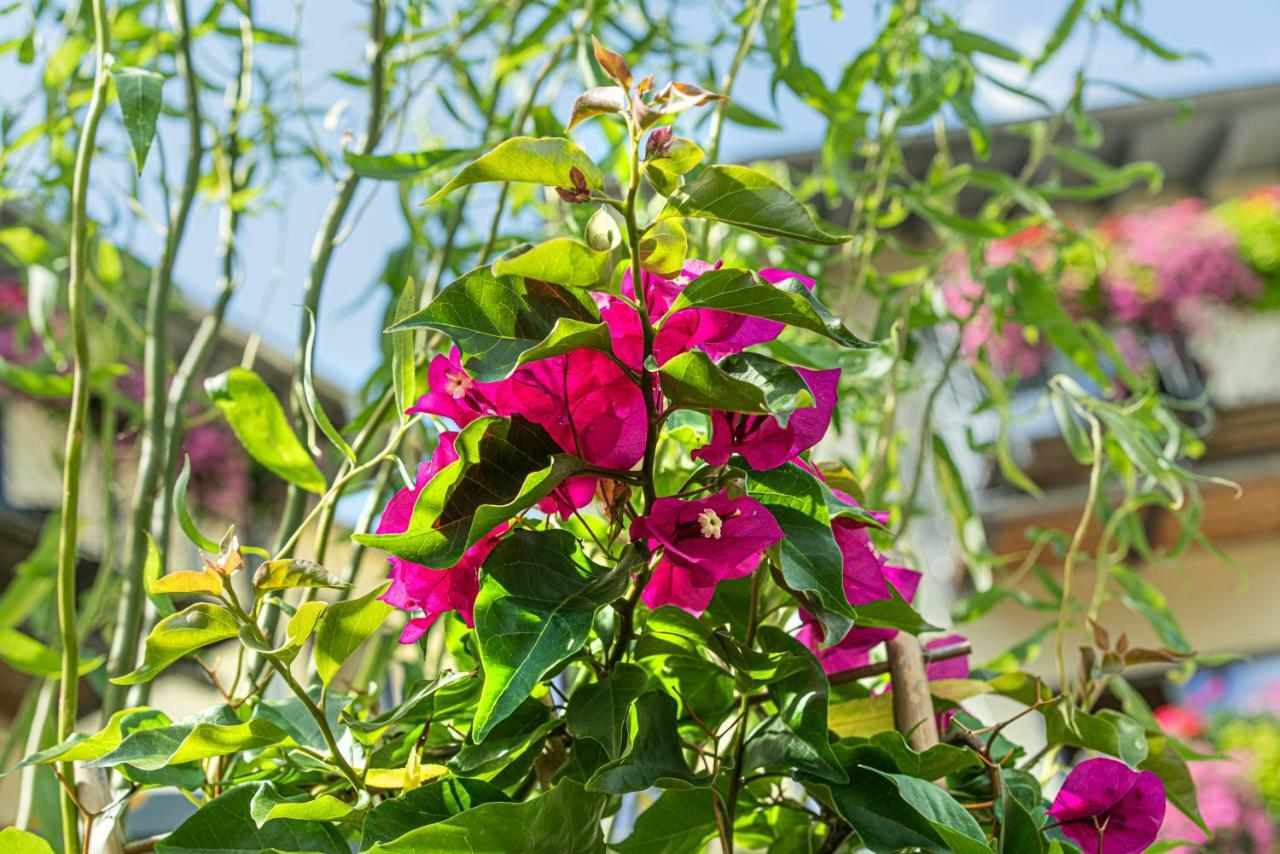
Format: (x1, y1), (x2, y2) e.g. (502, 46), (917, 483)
(631, 493), (782, 615)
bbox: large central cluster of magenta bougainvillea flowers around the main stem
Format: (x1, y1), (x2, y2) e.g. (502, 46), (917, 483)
(378, 260), (845, 643)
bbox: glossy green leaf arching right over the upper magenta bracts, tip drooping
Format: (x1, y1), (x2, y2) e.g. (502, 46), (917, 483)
(667, 268), (873, 350)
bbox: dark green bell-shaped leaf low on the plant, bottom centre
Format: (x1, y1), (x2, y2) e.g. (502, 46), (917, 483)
(586, 691), (710, 795)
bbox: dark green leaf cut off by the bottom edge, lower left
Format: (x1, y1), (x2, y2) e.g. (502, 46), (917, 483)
(156, 784), (351, 854)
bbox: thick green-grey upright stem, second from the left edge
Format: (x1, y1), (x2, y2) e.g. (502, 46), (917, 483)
(102, 0), (205, 721)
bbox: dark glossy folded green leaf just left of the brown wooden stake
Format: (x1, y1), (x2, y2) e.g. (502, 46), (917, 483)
(741, 626), (849, 782)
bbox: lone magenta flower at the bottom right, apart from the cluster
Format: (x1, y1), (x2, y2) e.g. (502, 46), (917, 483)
(1048, 758), (1165, 854)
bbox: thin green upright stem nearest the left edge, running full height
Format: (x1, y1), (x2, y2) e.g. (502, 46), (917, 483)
(58, 0), (110, 854)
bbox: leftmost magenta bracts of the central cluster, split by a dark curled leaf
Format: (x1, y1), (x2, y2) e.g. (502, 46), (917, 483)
(376, 433), (507, 644)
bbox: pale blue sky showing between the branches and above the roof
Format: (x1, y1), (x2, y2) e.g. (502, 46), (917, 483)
(10, 0), (1280, 389)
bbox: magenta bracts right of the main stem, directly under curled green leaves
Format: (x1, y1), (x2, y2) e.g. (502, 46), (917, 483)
(692, 367), (840, 471)
